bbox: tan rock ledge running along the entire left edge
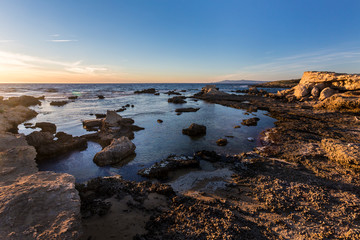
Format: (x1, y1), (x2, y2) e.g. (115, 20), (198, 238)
(0, 97), (81, 239)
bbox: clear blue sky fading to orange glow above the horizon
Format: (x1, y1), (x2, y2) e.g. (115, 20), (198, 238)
(0, 0), (360, 83)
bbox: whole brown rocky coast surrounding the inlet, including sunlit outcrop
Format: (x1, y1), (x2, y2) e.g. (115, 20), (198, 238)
(0, 72), (360, 239)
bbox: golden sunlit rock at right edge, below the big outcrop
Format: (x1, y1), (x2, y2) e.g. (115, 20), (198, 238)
(321, 139), (360, 169)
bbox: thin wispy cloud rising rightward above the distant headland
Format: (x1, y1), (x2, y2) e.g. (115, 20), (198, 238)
(217, 48), (360, 80)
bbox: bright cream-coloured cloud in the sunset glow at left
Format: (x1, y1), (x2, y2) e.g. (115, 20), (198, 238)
(0, 51), (108, 75)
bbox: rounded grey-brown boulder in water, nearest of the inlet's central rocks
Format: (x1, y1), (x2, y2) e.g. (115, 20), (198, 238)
(94, 137), (136, 166)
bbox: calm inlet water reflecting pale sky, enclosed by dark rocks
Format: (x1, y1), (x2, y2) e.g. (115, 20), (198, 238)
(10, 86), (274, 182)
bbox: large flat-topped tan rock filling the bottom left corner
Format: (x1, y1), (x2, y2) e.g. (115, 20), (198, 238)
(0, 172), (81, 240)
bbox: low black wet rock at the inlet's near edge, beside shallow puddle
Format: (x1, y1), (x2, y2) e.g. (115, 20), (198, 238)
(138, 155), (199, 179)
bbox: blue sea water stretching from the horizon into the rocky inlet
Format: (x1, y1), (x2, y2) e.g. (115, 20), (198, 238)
(0, 84), (278, 182)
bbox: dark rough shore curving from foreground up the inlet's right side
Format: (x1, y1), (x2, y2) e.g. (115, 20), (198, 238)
(2, 75), (360, 239)
